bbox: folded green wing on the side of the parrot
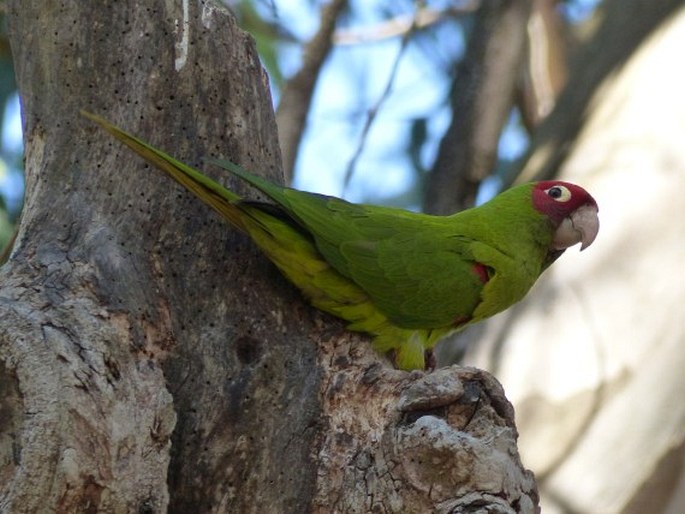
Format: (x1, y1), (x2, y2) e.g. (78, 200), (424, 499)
(212, 158), (483, 329)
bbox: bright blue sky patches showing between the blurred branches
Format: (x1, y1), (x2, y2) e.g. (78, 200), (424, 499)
(0, 0), (598, 214)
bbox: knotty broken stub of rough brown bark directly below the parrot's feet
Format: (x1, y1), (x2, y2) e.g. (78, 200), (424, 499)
(313, 330), (538, 514)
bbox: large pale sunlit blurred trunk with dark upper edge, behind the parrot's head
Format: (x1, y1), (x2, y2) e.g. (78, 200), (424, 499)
(469, 0), (685, 514)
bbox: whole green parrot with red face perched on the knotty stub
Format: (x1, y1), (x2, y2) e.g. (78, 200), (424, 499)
(82, 112), (599, 370)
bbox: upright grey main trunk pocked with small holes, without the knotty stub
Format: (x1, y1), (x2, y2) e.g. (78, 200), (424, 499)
(0, 1), (319, 512)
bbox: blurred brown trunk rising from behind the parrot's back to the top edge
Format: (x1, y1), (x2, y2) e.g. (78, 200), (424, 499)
(424, 0), (530, 214)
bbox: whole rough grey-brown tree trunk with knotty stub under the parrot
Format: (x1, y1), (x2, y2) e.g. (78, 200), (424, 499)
(0, 0), (537, 513)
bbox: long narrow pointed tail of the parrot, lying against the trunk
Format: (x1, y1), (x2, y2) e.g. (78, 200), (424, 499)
(81, 111), (245, 230)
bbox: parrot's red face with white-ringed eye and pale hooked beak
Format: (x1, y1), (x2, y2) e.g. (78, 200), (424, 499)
(533, 180), (599, 250)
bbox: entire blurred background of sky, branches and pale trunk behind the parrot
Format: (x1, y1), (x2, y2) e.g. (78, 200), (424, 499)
(0, 0), (685, 514)
